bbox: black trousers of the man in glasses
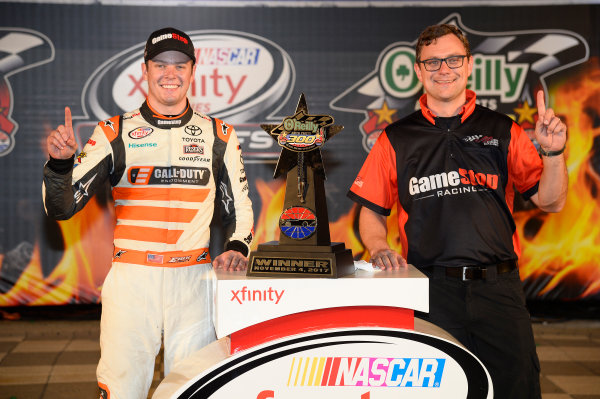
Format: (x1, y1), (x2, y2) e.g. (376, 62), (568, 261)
(415, 269), (541, 399)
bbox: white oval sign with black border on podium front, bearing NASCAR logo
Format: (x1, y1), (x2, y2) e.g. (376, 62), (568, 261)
(171, 328), (493, 399)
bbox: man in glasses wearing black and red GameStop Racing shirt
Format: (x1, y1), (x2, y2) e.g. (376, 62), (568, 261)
(348, 25), (567, 399)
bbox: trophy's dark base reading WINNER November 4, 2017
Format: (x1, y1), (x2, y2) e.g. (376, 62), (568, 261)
(246, 241), (354, 278)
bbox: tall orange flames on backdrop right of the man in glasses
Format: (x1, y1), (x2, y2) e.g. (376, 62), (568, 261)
(515, 59), (600, 300)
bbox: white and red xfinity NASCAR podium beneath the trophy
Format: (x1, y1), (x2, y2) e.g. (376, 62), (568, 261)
(153, 265), (493, 399)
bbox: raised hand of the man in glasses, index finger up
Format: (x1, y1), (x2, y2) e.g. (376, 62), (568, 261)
(535, 90), (567, 152)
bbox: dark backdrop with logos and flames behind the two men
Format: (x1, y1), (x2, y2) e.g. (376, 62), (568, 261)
(0, 2), (600, 307)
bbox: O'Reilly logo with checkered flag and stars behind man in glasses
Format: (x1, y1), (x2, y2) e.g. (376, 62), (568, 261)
(329, 14), (589, 152)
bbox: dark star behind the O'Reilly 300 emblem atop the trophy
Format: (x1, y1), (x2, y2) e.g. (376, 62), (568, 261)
(260, 93), (344, 179)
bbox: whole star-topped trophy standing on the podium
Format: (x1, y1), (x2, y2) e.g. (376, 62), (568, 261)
(246, 94), (354, 278)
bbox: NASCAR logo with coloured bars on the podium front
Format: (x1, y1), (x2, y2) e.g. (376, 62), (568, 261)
(287, 357), (446, 388)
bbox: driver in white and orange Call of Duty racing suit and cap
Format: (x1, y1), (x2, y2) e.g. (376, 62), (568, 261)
(43, 28), (253, 399)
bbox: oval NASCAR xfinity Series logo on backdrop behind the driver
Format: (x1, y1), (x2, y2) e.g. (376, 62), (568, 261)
(79, 30), (295, 162)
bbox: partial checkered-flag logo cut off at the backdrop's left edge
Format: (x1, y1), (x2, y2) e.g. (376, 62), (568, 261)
(0, 28), (54, 157)
